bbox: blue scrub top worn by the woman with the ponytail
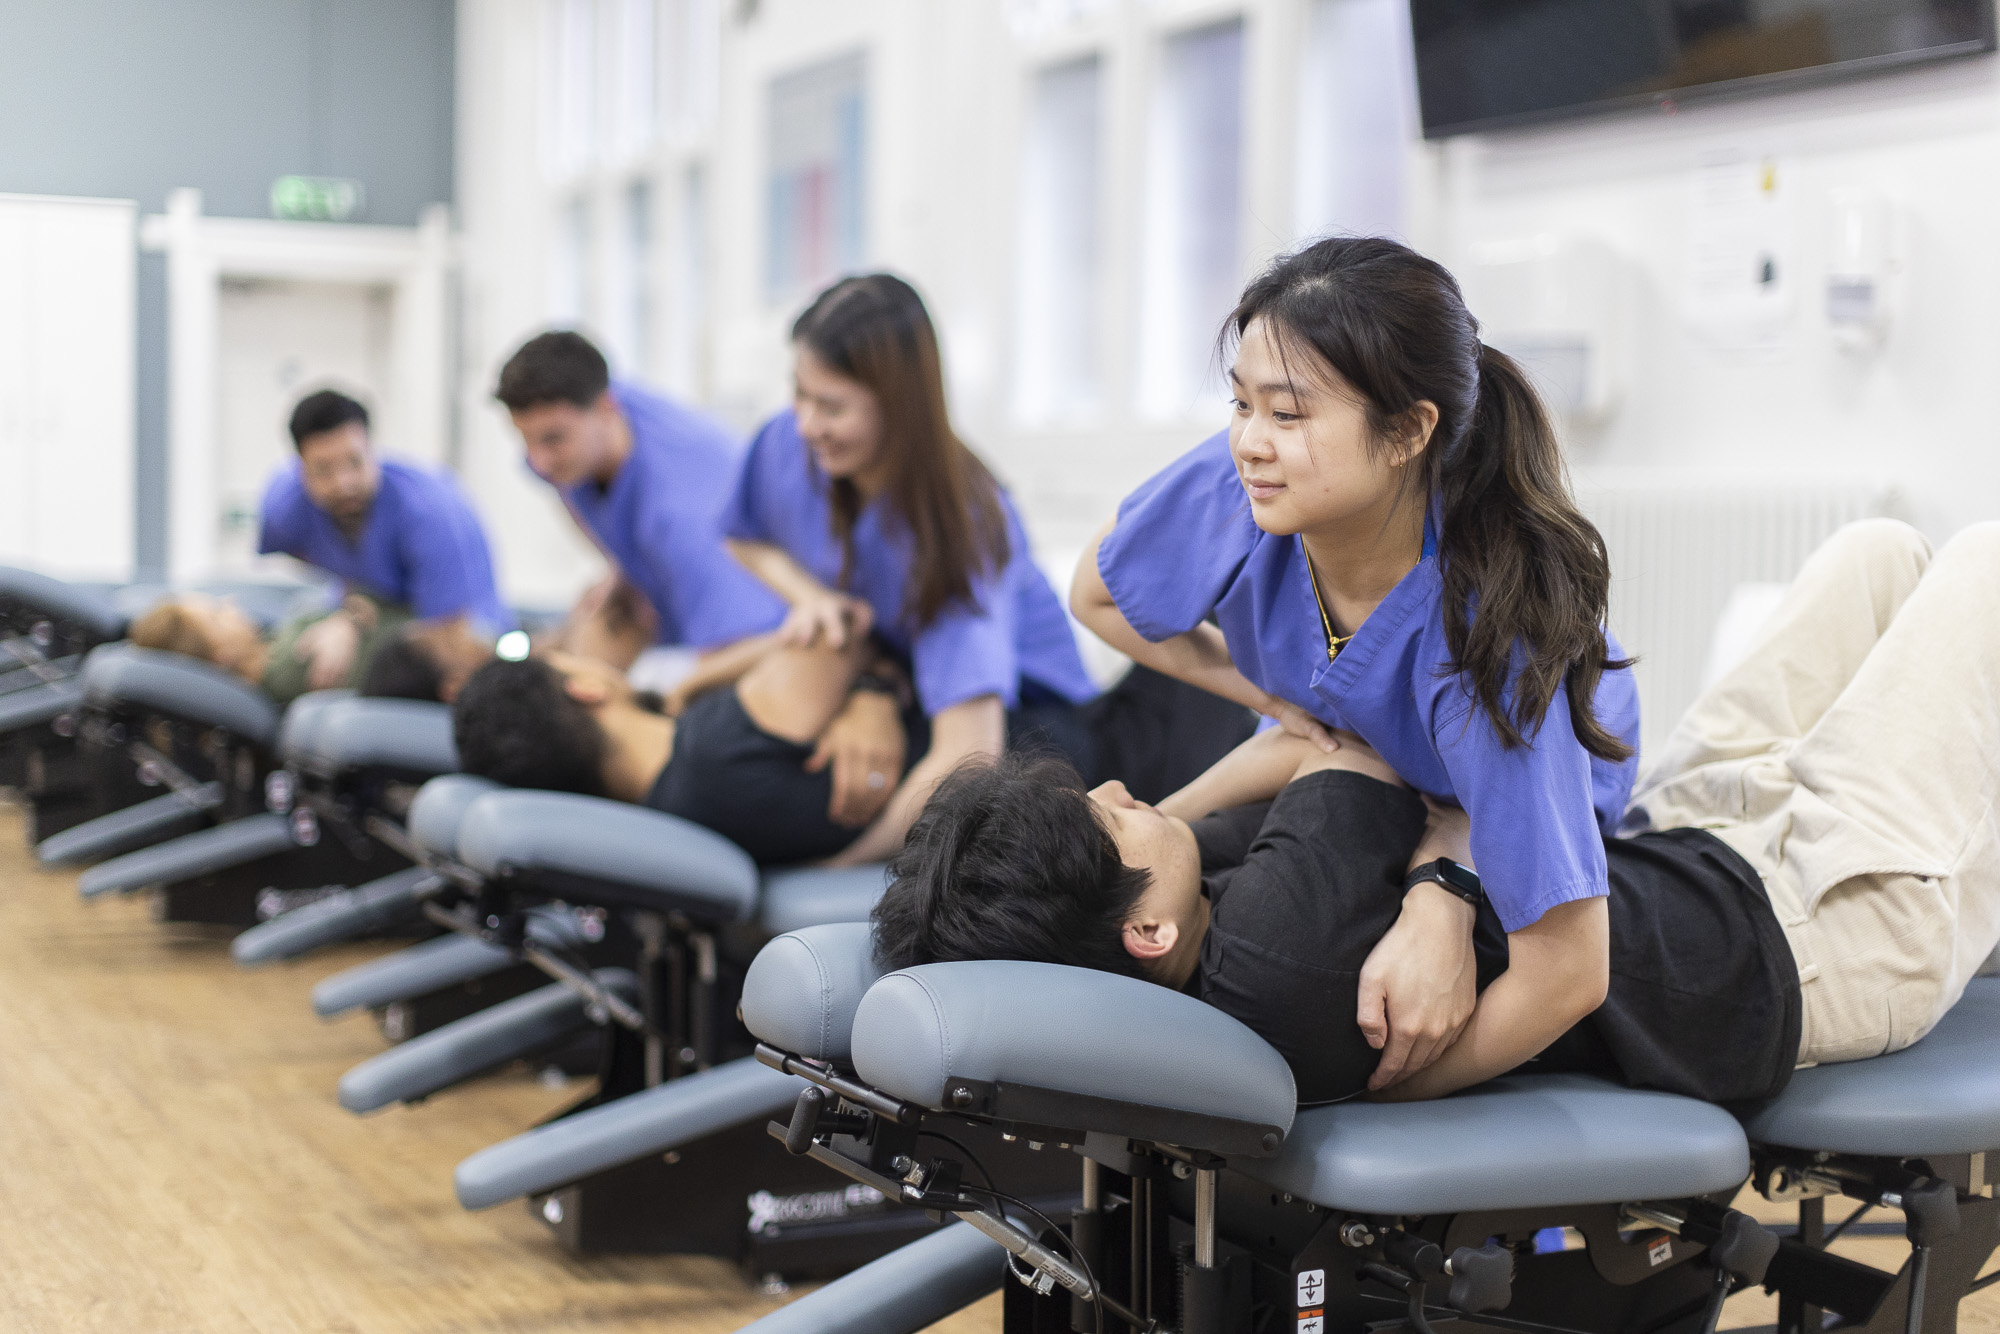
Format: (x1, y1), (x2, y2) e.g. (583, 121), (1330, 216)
(1098, 432), (1638, 932)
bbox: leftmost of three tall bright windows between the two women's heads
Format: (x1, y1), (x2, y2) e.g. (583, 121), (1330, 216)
(1014, 56), (1102, 422)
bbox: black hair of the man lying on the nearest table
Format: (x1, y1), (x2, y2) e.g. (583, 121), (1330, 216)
(874, 752), (1150, 978)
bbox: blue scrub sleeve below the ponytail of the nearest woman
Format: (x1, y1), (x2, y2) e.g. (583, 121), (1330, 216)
(1436, 686), (1610, 932)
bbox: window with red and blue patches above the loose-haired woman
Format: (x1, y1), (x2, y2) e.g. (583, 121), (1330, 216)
(766, 54), (866, 302)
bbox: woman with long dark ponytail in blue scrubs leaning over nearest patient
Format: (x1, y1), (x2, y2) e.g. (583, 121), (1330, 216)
(1072, 238), (1638, 1092)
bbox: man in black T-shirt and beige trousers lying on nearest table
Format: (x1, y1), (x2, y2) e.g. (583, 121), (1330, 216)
(876, 520), (2000, 1102)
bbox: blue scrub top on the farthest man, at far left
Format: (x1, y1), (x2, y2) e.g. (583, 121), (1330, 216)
(256, 458), (514, 634)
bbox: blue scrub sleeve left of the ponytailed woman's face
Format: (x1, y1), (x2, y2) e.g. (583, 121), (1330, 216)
(1098, 432), (1258, 644)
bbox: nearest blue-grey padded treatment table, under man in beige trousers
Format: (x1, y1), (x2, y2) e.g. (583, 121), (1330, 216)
(742, 926), (2000, 1334)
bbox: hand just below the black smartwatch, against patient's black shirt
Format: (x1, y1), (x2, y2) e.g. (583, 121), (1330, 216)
(1354, 880), (1478, 1090)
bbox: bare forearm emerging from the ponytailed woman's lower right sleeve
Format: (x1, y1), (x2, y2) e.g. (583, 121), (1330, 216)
(1376, 898), (1610, 1102)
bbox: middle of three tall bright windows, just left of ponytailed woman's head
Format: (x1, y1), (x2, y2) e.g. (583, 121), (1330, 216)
(1138, 20), (1244, 418)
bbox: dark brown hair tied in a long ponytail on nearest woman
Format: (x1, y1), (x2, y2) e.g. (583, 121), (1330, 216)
(1224, 236), (1632, 760)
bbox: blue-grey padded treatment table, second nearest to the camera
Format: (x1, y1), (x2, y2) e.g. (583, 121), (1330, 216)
(320, 780), (1068, 1276)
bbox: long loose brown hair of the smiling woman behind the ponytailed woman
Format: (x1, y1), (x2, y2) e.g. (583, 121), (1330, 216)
(792, 274), (1010, 628)
